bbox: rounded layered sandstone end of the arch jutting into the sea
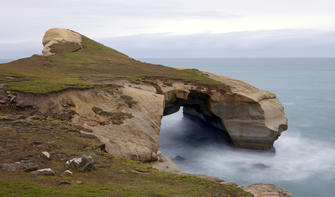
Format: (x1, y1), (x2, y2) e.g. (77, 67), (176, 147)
(206, 73), (287, 149)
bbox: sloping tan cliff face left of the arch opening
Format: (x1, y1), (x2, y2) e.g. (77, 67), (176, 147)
(7, 86), (164, 161)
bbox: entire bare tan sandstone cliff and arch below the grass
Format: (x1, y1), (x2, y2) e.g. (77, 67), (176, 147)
(1, 74), (287, 161)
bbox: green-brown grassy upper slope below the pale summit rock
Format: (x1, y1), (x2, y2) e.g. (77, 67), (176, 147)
(0, 36), (220, 93)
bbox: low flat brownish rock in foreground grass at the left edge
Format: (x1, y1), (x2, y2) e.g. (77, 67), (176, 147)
(0, 160), (38, 172)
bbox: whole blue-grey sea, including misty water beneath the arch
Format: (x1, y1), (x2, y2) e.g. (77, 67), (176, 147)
(142, 58), (335, 197)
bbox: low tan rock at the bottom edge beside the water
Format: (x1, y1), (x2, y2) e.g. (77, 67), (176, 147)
(243, 183), (293, 197)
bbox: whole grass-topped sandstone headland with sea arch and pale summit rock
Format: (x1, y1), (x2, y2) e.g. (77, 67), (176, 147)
(0, 28), (290, 196)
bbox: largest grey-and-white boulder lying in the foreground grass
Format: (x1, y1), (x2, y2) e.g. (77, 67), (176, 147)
(65, 155), (94, 172)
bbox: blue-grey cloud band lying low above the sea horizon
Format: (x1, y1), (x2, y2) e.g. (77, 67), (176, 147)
(97, 30), (335, 58)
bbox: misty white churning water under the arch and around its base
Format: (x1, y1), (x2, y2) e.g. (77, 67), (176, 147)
(160, 112), (335, 184)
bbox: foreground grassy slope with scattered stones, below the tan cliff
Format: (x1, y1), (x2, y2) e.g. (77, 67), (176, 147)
(0, 110), (251, 197)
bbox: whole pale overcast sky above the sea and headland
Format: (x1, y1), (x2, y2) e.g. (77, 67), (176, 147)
(0, 0), (335, 59)
